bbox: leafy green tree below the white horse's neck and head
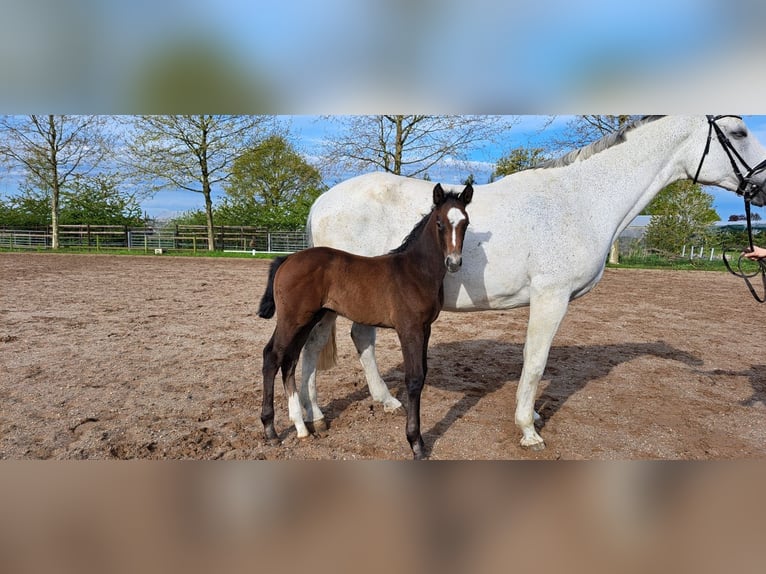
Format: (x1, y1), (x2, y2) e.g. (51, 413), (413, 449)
(644, 180), (720, 253)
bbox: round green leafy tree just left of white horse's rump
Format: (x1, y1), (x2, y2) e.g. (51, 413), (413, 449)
(217, 134), (325, 229)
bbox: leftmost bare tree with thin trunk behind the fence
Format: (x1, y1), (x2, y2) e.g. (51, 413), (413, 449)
(0, 115), (111, 249)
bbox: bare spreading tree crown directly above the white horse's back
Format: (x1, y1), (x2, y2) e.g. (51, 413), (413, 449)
(324, 115), (513, 177)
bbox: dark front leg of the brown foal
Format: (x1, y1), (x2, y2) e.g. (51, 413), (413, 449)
(397, 324), (431, 460)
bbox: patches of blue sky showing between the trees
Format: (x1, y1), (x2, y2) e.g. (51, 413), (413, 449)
(142, 115), (766, 225)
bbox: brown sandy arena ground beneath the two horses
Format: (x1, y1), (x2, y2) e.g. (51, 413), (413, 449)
(0, 253), (766, 460)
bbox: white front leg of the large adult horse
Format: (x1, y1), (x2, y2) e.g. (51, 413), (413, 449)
(516, 290), (570, 450)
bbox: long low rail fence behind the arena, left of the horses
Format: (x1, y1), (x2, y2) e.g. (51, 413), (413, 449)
(0, 225), (308, 253)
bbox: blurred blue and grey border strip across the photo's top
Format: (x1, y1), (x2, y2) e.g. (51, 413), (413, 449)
(0, 0), (766, 114)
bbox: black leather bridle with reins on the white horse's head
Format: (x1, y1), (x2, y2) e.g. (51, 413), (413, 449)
(694, 115), (766, 303)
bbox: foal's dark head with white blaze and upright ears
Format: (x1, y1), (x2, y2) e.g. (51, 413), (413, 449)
(432, 183), (473, 273)
